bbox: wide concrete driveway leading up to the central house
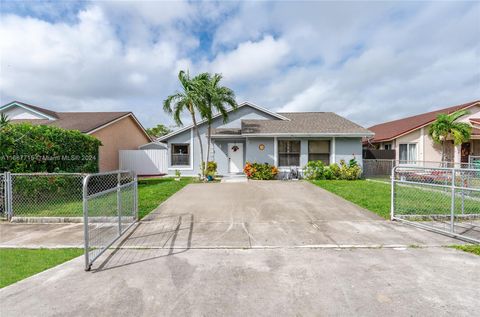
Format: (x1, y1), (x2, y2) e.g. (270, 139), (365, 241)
(0, 182), (480, 316)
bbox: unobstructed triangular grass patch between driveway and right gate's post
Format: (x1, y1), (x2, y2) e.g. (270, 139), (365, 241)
(312, 180), (390, 219)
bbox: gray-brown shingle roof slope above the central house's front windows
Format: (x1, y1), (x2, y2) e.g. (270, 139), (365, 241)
(242, 112), (372, 136)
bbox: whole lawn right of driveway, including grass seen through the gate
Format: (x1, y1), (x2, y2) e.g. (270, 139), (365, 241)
(312, 180), (480, 220)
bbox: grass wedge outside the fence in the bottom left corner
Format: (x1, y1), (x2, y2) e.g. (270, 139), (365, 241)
(0, 249), (83, 288)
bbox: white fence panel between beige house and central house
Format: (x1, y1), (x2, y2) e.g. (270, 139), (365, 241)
(120, 149), (168, 175)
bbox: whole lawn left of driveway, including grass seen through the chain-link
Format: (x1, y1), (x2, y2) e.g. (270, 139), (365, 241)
(14, 177), (195, 219)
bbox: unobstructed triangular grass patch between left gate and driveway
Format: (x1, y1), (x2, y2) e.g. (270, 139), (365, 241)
(138, 177), (195, 219)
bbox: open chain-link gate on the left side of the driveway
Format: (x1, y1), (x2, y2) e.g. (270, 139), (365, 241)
(83, 171), (138, 270)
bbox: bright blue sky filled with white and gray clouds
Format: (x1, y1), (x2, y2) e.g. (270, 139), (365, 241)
(0, 0), (480, 127)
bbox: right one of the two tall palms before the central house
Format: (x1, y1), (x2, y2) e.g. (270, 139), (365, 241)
(202, 73), (237, 165)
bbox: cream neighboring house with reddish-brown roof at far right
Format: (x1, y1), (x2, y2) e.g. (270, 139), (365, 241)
(366, 100), (480, 163)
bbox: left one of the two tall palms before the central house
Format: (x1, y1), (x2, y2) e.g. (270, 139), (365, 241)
(163, 70), (206, 176)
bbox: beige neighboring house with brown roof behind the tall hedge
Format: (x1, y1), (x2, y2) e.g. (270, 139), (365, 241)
(0, 101), (151, 172)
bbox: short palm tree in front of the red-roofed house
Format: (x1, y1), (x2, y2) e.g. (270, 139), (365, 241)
(428, 110), (472, 162)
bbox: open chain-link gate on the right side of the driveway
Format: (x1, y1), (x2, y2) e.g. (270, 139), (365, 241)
(391, 166), (480, 243)
